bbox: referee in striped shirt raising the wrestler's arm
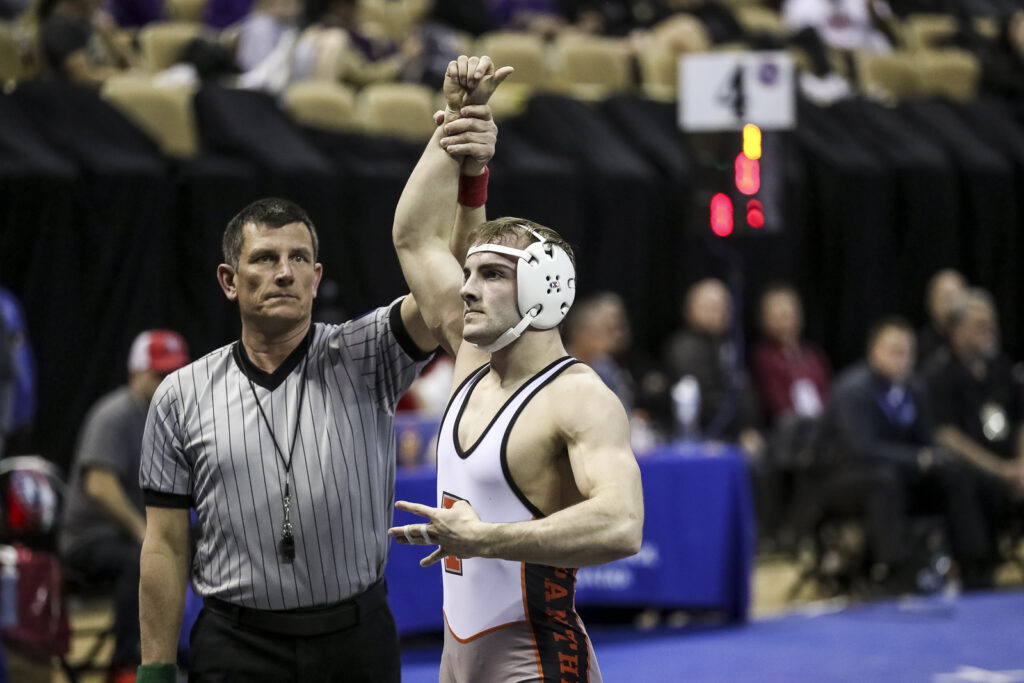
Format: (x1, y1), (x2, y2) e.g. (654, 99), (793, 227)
(138, 97), (496, 683)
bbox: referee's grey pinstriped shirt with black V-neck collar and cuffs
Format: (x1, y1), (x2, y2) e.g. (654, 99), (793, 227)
(139, 302), (425, 609)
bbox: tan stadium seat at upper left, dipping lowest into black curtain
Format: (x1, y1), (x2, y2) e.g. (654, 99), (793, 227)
(100, 76), (199, 159)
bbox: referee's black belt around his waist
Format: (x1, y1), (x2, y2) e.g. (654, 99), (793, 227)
(204, 579), (387, 637)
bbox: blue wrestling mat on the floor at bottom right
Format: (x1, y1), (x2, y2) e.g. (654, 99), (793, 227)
(402, 591), (1024, 683)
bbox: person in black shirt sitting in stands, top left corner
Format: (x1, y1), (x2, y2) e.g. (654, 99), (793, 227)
(38, 0), (135, 87)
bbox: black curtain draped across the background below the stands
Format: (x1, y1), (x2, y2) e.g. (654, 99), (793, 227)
(0, 83), (1024, 465)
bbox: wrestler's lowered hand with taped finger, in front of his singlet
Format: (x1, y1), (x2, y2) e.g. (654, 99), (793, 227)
(387, 501), (488, 567)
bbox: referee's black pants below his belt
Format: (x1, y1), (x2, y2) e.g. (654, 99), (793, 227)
(188, 590), (401, 683)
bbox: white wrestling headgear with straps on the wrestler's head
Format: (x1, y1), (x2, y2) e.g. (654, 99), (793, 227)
(466, 225), (575, 353)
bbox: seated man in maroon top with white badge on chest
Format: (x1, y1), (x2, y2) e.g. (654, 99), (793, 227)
(753, 285), (829, 424)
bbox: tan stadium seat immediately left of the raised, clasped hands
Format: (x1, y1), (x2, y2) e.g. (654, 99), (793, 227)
(355, 83), (436, 141)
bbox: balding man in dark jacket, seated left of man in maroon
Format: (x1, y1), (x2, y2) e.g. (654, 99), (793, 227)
(663, 279), (764, 458)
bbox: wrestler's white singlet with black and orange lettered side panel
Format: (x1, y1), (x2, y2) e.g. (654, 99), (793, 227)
(437, 356), (601, 683)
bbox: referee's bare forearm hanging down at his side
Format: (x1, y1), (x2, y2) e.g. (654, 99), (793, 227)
(138, 536), (188, 664)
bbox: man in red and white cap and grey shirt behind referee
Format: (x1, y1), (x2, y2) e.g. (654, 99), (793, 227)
(59, 330), (189, 681)
